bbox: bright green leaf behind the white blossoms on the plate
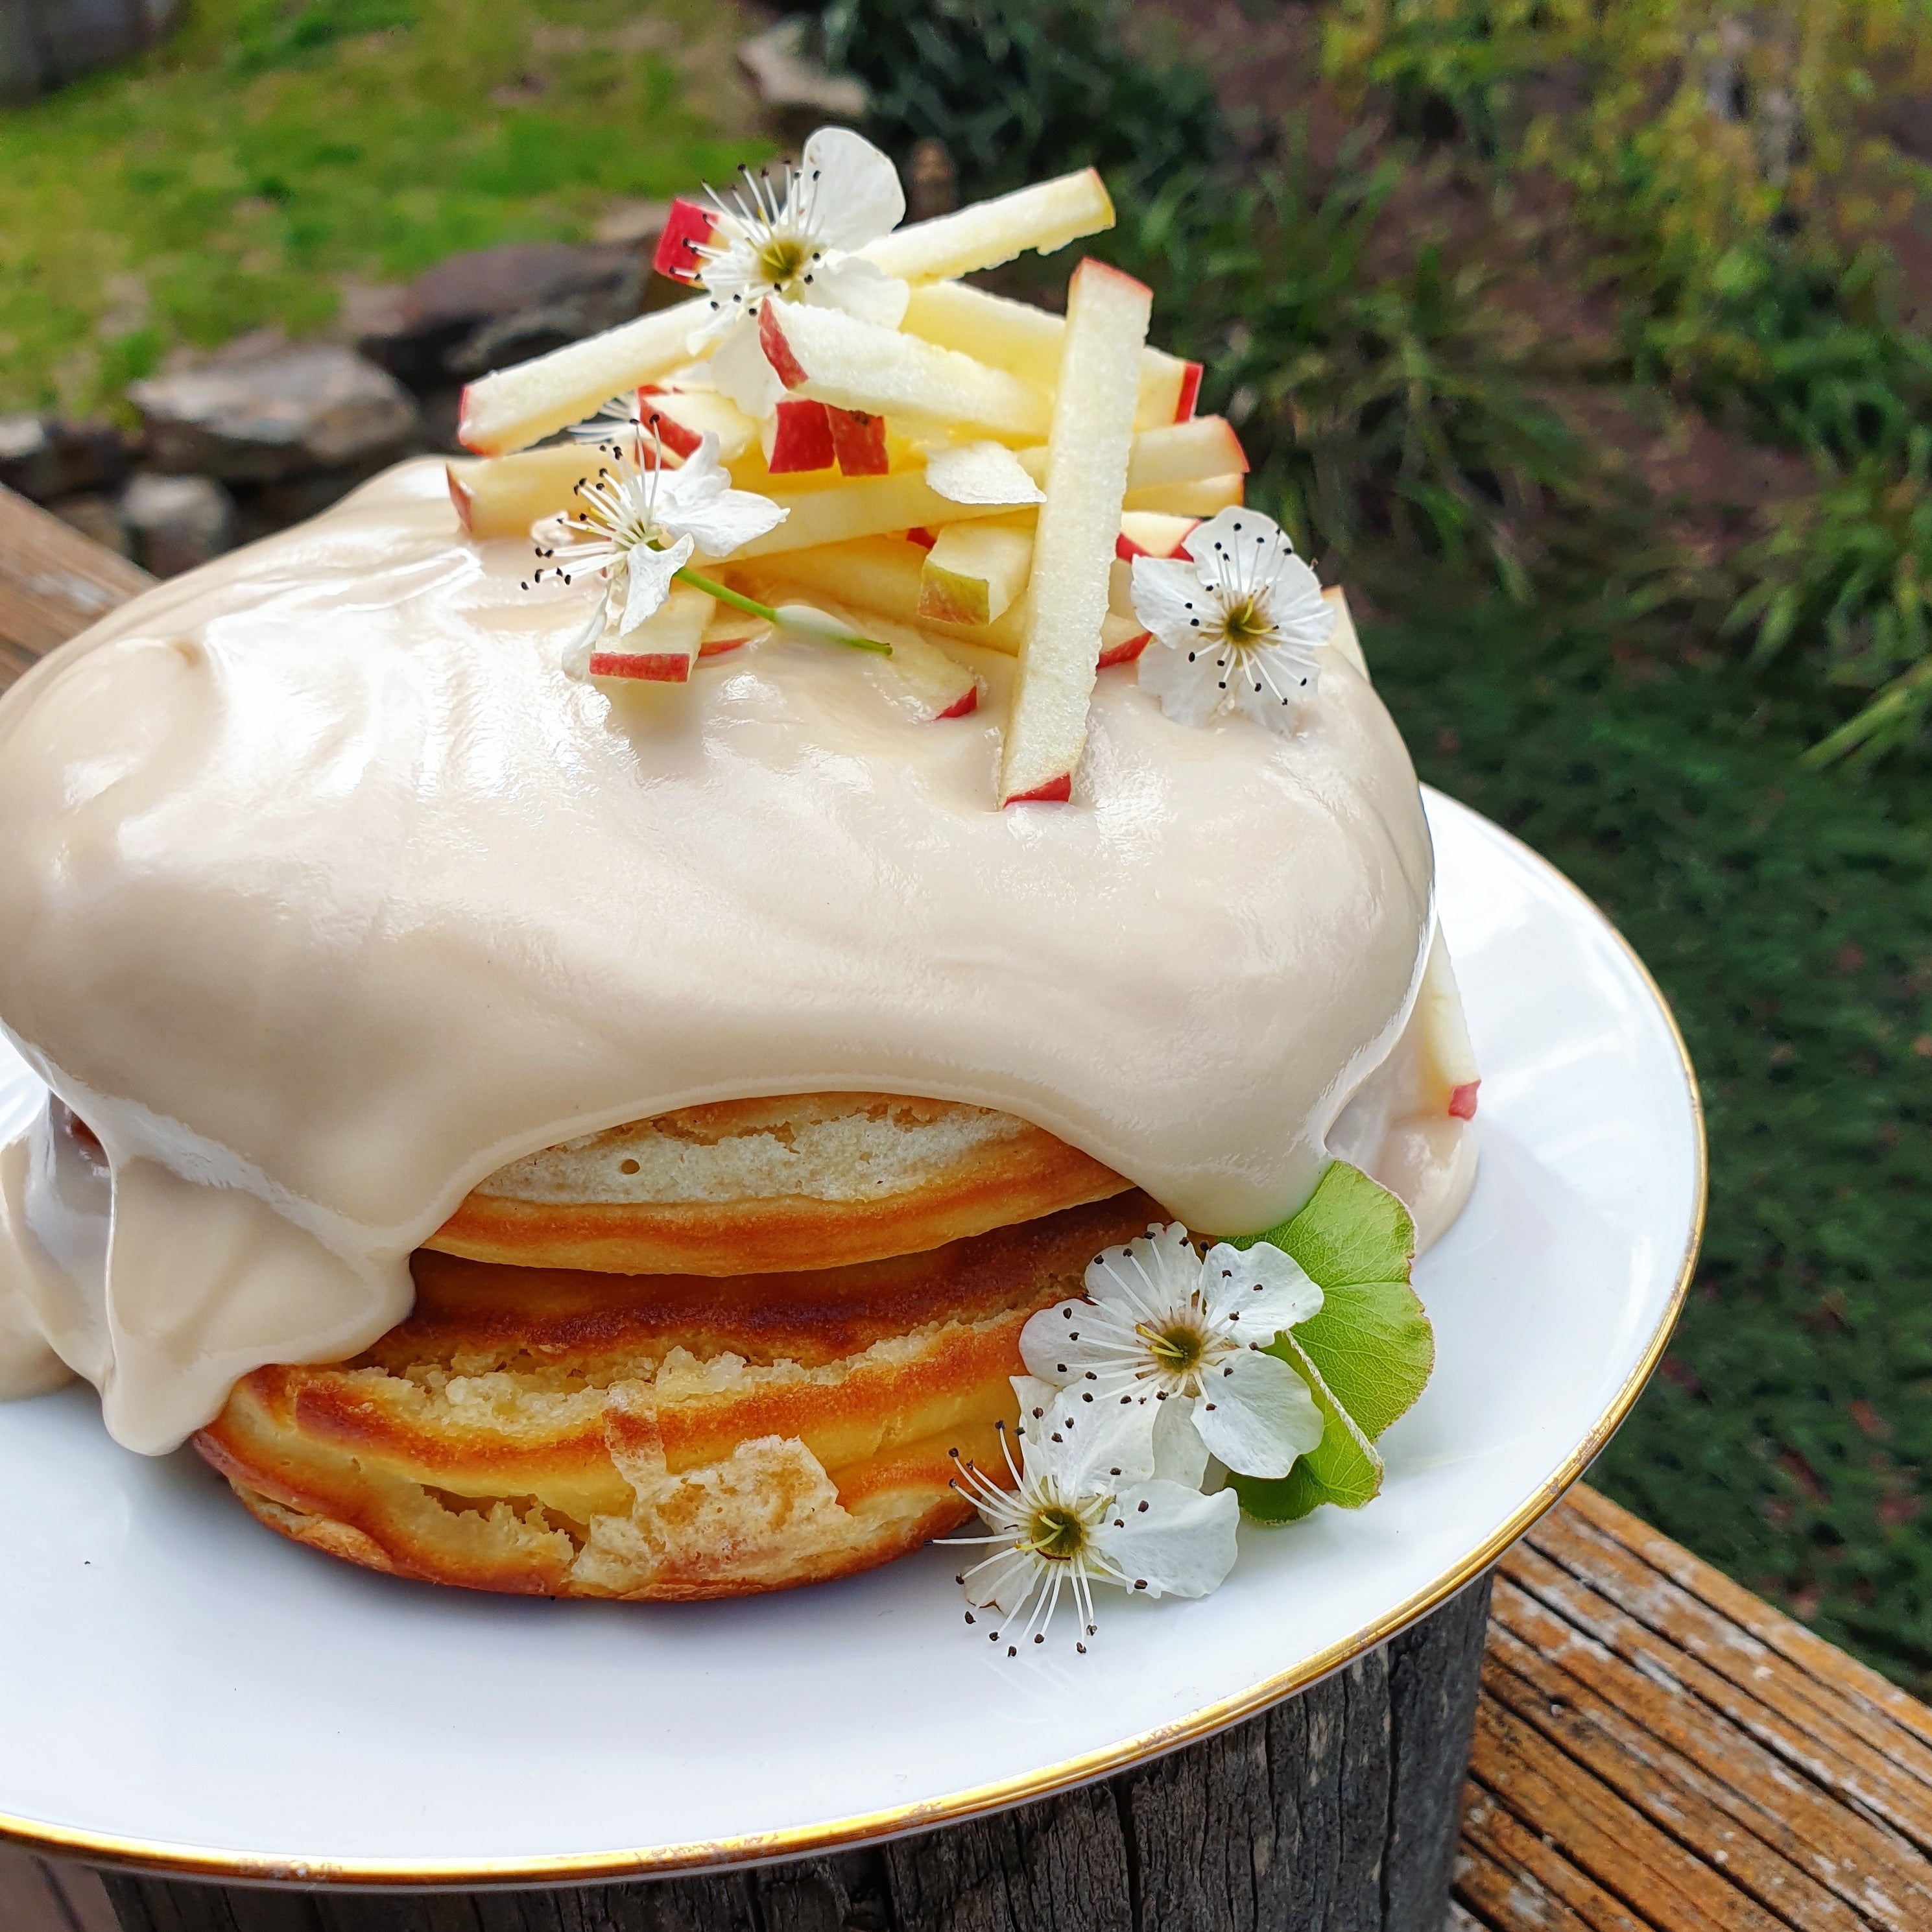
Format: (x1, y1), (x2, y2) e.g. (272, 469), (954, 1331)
(1231, 1161), (1435, 1522)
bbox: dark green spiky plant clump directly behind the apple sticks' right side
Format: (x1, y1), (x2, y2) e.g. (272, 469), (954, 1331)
(1097, 137), (1590, 601)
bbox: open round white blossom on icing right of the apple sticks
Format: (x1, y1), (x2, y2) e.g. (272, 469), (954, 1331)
(1134, 510), (1335, 730)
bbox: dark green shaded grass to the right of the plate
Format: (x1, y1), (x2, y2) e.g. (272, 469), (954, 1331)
(1364, 566), (1932, 1693)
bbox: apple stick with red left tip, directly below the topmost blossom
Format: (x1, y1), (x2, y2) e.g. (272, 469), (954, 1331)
(757, 302), (1047, 436)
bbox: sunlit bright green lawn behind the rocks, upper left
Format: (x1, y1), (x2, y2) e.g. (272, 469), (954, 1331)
(0, 0), (765, 414)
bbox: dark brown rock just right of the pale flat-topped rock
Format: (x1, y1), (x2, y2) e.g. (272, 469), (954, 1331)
(361, 241), (663, 388)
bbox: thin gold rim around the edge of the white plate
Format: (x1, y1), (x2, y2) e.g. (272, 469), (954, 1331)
(0, 786), (1710, 1889)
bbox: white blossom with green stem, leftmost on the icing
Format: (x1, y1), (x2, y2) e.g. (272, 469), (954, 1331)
(531, 431), (790, 678)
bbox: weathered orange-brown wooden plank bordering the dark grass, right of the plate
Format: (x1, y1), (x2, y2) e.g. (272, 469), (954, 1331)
(1507, 1511), (1932, 1847)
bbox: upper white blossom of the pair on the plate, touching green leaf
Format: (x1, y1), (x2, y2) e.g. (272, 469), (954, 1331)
(1020, 1221), (1322, 1482)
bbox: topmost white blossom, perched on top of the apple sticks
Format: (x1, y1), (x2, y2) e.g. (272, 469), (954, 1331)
(691, 128), (908, 348)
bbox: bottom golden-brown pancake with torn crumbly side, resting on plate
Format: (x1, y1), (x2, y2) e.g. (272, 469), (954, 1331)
(195, 1192), (1159, 1602)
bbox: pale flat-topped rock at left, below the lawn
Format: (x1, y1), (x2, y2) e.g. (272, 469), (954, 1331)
(128, 332), (415, 483)
